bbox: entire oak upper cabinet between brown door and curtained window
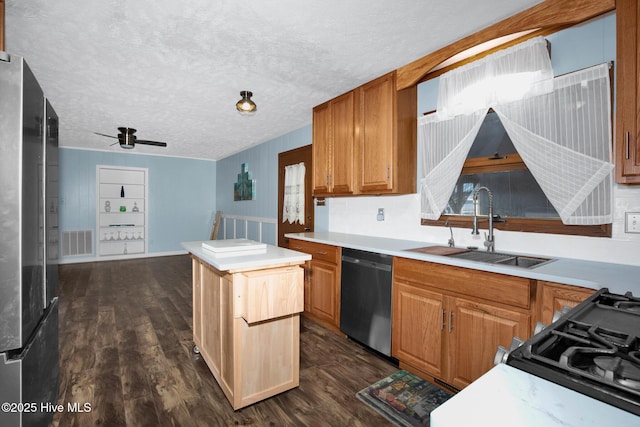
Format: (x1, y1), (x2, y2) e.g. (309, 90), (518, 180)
(313, 72), (418, 196)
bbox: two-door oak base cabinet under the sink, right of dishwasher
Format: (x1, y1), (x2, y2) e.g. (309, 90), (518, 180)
(392, 258), (534, 389)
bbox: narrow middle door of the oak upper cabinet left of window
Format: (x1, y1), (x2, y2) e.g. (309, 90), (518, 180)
(330, 91), (355, 194)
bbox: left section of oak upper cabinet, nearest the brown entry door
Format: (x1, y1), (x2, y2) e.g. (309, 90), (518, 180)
(312, 91), (356, 196)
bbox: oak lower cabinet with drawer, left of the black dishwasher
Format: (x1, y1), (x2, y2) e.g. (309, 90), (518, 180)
(289, 239), (342, 332)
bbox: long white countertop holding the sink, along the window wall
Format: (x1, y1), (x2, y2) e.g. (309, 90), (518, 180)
(286, 232), (640, 296)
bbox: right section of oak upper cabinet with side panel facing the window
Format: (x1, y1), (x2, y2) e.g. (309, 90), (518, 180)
(357, 71), (418, 194)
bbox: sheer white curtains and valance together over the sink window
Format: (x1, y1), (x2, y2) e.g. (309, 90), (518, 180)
(418, 38), (613, 225)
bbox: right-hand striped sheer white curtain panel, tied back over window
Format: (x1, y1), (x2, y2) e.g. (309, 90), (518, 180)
(494, 64), (613, 225)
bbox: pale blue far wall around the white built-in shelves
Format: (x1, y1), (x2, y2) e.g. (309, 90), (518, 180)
(59, 148), (216, 261)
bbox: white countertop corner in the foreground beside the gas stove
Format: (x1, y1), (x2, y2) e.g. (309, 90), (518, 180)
(431, 364), (640, 427)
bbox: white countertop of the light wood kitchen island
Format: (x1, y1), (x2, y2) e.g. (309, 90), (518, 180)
(182, 241), (311, 271)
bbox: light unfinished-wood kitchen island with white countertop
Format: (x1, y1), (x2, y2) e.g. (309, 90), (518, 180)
(182, 241), (311, 410)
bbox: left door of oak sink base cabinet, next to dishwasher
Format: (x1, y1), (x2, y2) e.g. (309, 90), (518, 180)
(391, 281), (444, 377)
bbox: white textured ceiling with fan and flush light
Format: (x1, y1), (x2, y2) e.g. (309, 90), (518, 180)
(5, 0), (540, 160)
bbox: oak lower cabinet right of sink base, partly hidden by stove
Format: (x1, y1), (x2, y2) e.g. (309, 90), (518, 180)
(537, 281), (596, 325)
